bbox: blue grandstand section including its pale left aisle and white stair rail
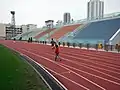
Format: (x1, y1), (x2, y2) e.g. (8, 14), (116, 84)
(60, 17), (120, 45)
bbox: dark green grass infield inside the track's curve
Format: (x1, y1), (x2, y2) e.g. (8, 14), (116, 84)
(0, 45), (48, 90)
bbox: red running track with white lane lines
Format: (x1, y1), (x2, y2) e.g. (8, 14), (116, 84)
(0, 40), (120, 90)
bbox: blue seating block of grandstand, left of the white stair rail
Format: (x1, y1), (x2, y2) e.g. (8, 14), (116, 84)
(73, 18), (120, 43)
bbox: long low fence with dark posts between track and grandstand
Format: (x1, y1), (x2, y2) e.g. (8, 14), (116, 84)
(17, 38), (120, 53)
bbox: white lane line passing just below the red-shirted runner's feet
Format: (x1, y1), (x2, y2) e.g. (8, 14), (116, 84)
(22, 49), (106, 90)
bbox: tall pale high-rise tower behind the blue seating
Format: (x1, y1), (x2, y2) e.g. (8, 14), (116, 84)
(87, 0), (104, 20)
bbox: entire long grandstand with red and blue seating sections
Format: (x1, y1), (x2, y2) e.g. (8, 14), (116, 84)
(12, 14), (120, 45)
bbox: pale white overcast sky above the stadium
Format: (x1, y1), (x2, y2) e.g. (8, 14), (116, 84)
(0, 0), (120, 27)
